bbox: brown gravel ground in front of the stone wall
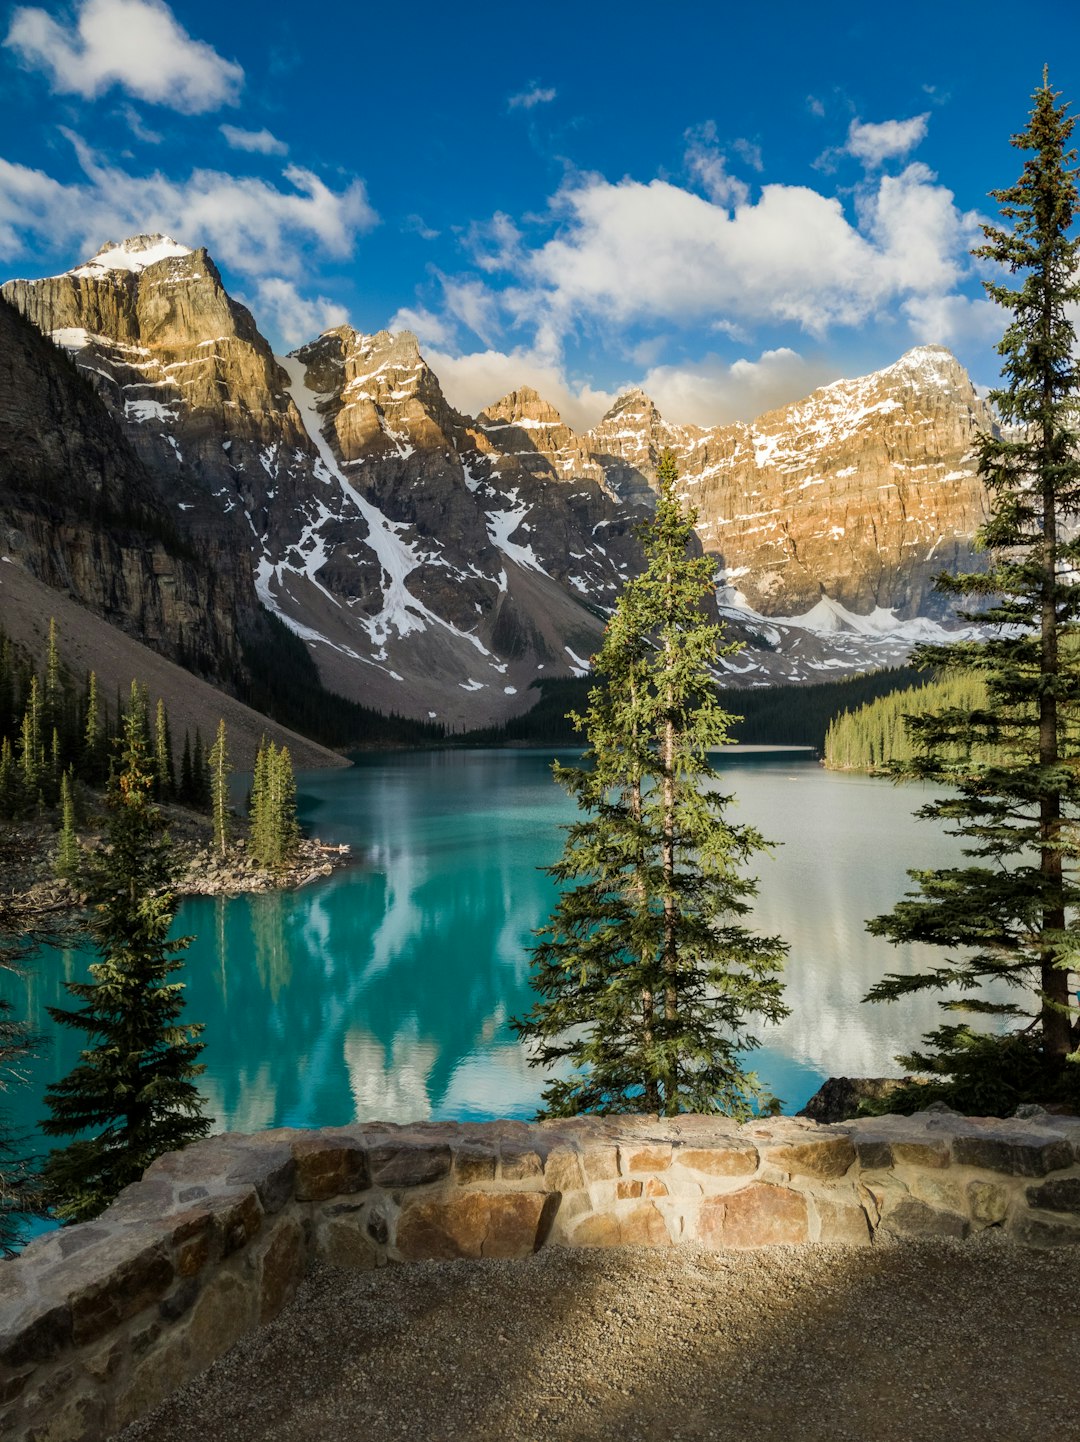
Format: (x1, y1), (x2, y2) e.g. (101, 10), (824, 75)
(118, 1233), (1080, 1442)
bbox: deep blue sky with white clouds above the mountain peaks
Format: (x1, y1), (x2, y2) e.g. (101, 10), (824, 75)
(0, 0), (1080, 425)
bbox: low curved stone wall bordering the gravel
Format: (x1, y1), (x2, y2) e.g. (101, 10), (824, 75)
(0, 1109), (1080, 1442)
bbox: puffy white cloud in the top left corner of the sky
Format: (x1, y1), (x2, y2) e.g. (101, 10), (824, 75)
(4, 0), (244, 115)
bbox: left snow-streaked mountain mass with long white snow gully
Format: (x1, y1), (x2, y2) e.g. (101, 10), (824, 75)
(3, 243), (640, 725)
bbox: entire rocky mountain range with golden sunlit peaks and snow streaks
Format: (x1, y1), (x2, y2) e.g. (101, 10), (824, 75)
(3, 235), (992, 727)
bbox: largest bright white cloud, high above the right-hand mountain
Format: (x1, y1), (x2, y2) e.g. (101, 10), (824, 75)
(456, 164), (975, 343)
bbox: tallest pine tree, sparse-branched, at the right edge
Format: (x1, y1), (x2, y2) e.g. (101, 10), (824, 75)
(869, 72), (1080, 1094)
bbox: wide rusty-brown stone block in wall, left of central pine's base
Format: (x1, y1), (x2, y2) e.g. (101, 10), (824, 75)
(397, 1191), (559, 1262)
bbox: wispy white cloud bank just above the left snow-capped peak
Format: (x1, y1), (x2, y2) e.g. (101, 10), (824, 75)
(0, 131), (378, 275)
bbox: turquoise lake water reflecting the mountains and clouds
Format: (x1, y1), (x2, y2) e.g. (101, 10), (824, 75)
(4, 750), (959, 1131)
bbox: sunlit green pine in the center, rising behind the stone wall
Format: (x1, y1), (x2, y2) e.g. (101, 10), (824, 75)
(515, 453), (787, 1116)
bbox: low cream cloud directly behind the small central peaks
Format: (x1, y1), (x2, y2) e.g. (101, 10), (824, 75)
(424, 346), (617, 431)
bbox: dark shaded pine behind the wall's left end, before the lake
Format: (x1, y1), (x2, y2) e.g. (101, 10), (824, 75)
(42, 703), (212, 1221)
